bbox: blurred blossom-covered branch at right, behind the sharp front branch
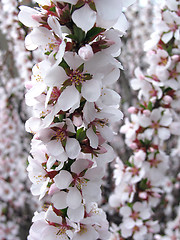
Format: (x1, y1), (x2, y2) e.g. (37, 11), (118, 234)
(109, 1), (180, 240)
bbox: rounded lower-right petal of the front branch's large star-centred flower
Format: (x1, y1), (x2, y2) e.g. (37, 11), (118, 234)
(81, 79), (102, 102)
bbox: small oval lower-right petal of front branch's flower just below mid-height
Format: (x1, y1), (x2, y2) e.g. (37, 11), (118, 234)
(65, 138), (81, 159)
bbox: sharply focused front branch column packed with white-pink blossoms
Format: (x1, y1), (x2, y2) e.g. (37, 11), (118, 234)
(19, 0), (134, 240)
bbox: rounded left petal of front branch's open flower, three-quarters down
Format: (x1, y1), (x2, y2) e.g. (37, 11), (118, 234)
(54, 170), (73, 189)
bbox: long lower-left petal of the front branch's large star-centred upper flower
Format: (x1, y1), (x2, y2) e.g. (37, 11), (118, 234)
(55, 86), (80, 112)
